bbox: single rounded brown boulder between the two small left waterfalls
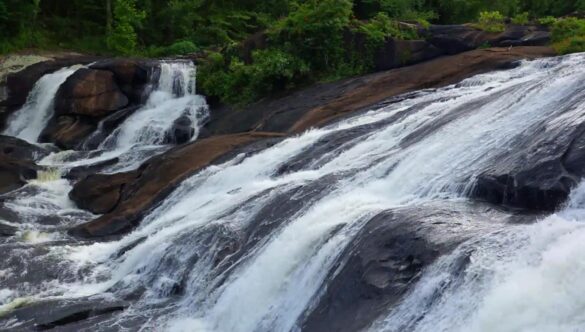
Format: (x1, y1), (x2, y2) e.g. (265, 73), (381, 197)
(55, 68), (129, 118)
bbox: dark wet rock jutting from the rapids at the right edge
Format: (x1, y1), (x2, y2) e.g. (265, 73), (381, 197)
(472, 119), (585, 211)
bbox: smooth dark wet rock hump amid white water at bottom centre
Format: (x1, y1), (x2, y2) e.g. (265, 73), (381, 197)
(302, 203), (536, 332)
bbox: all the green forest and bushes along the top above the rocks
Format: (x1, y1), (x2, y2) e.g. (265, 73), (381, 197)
(0, 0), (585, 104)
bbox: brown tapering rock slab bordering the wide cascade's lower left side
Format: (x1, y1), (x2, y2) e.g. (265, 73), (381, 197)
(70, 132), (280, 239)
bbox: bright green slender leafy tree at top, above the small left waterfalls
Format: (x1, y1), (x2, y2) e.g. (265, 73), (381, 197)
(107, 0), (146, 55)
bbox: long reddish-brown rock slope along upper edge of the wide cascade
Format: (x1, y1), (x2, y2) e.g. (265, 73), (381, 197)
(289, 47), (555, 133)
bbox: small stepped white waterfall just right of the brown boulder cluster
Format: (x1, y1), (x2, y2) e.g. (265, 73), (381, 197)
(41, 61), (208, 173)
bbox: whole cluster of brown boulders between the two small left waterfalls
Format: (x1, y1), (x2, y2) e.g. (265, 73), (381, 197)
(40, 59), (159, 149)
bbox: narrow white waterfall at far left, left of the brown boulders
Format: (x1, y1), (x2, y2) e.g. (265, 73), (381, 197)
(3, 66), (79, 143)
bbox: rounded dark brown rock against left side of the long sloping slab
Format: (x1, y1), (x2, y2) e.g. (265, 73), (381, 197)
(69, 172), (137, 214)
